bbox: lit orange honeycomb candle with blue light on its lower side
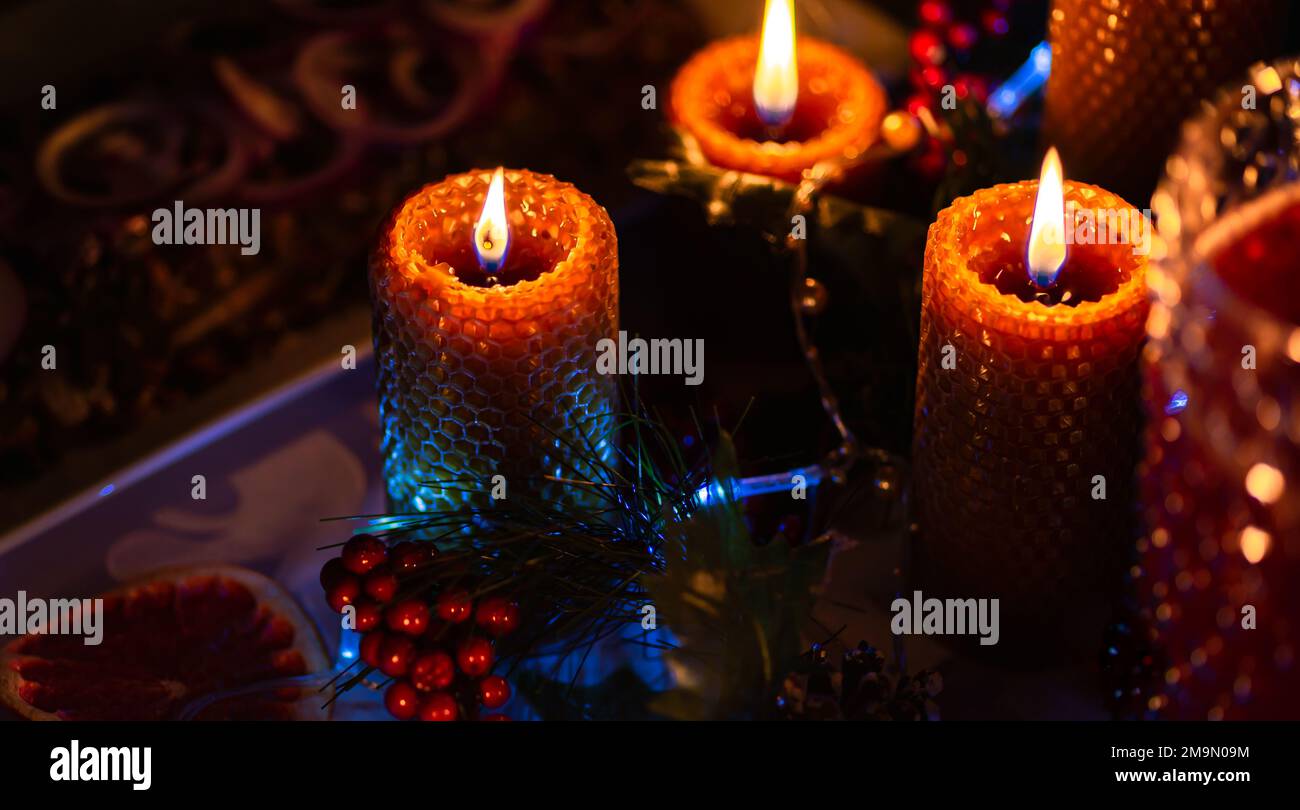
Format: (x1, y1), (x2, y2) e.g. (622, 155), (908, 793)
(371, 172), (619, 511)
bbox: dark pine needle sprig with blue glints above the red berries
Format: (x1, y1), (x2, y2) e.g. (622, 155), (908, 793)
(322, 395), (711, 688)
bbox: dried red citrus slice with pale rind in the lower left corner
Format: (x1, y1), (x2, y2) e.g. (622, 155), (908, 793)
(0, 566), (329, 720)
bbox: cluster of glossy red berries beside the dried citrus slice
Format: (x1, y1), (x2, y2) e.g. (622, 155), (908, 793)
(321, 534), (519, 720)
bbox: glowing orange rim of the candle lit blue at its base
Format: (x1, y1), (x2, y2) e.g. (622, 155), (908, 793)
(380, 166), (618, 303)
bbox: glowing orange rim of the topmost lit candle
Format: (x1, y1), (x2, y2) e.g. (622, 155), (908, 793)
(670, 34), (889, 176)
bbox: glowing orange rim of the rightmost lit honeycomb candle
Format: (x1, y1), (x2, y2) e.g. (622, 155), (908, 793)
(926, 179), (1151, 328)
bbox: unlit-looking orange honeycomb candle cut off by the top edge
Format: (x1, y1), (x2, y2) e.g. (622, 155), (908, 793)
(1043, 0), (1286, 200)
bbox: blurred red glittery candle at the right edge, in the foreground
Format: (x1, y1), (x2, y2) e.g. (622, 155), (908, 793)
(1136, 186), (1300, 720)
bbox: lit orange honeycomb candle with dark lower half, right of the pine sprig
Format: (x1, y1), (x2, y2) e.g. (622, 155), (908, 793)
(913, 182), (1147, 624)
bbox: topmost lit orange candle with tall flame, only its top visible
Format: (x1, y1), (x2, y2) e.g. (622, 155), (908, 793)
(670, 0), (887, 181)
